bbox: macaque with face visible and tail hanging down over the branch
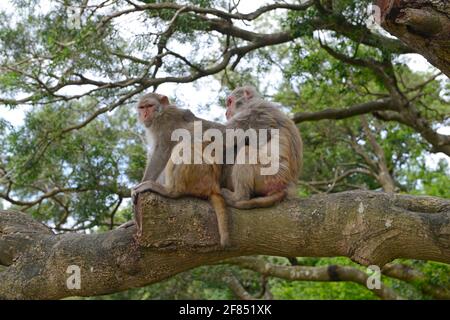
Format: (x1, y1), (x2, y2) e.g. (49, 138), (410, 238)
(132, 93), (229, 246)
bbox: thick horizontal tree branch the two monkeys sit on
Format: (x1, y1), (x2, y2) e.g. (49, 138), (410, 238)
(0, 191), (450, 299)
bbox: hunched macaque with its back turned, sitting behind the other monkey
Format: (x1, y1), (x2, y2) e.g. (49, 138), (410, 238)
(222, 86), (303, 209)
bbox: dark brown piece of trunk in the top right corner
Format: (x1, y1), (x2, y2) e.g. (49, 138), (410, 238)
(377, 0), (450, 77)
